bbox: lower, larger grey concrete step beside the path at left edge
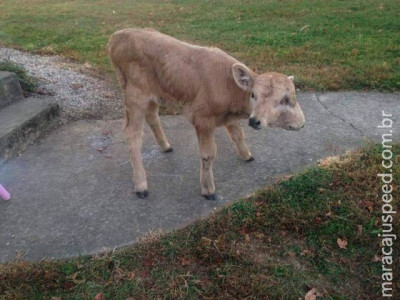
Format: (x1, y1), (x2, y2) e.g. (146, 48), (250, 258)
(0, 98), (60, 165)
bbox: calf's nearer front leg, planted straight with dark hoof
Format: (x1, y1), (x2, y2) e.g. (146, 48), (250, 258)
(196, 128), (217, 200)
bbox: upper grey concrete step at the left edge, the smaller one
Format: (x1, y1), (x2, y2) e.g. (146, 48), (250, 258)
(0, 71), (23, 109)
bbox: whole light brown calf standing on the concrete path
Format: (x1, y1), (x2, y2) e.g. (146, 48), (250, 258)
(107, 29), (305, 200)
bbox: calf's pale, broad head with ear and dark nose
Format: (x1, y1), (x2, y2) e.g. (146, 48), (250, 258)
(232, 63), (305, 130)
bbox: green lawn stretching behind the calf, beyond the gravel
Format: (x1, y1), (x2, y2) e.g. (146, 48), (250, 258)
(0, 0), (400, 91)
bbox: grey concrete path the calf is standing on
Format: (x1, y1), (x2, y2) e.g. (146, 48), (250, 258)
(0, 92), (400, 262)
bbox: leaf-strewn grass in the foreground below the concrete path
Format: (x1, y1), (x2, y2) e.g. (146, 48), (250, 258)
(0, 144), (400, 299)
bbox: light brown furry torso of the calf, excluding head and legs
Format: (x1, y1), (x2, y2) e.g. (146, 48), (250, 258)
(107, 29), (249, 117)
